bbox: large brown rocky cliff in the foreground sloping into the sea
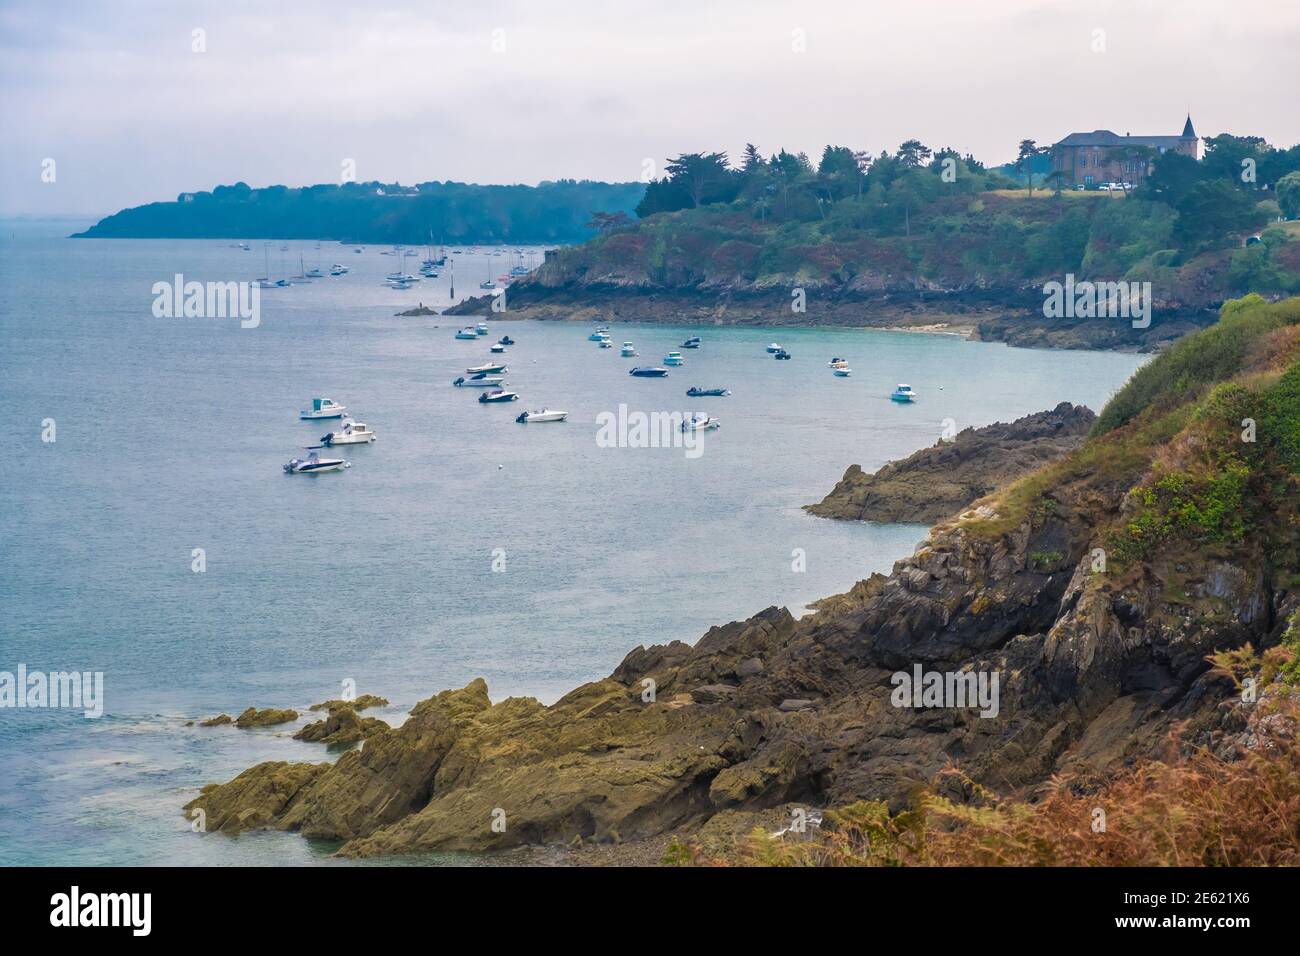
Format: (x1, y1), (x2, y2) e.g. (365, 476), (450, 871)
(190, 293), (1300, 857)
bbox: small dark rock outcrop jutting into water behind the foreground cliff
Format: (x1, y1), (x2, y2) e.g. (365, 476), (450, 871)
(803, 402), (1096, 524)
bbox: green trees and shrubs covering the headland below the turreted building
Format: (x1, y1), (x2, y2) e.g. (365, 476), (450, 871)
(536, 137), (1300, 308)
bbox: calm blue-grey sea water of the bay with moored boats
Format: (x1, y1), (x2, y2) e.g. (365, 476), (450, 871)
(0, 224), (1141, 865)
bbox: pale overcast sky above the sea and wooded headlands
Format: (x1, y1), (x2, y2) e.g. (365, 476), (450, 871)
(0, 0), (1300, 217)
